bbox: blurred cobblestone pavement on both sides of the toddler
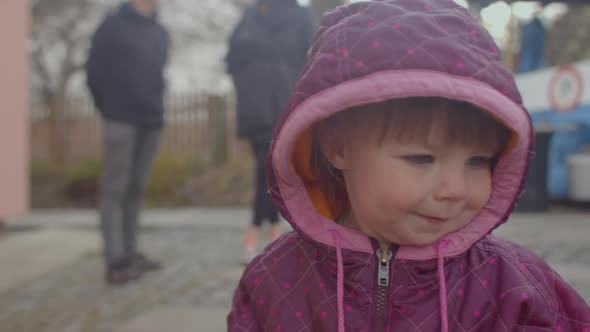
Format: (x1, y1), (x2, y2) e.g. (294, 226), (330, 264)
(0, 209), (590, 332)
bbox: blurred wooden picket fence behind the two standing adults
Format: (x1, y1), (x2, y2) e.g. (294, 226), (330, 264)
(30, 94), (241, 166)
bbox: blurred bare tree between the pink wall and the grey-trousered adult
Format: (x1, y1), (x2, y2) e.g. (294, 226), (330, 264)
(30, 0), (112, 165)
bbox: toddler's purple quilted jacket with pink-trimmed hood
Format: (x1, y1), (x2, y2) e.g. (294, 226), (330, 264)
(228, 0), (590, 332)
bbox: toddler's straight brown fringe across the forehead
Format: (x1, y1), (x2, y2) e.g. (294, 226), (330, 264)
(381, 98), (510, 152)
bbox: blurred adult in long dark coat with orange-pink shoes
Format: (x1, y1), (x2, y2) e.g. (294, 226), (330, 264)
(225, 0), (314, 260)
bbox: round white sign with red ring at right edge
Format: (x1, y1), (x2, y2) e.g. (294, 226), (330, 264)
(548, 65), (584, 112)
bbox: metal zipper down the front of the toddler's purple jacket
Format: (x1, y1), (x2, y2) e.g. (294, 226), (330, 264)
(375, 249), (393, 331)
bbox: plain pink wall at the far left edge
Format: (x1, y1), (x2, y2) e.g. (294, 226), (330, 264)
(0, 0), (29, 219)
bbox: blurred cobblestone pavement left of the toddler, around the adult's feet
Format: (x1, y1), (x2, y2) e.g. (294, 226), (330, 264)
(0, 213), (252, 332)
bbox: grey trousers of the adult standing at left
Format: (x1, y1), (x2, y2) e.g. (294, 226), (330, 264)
(100, 120), (161, 264)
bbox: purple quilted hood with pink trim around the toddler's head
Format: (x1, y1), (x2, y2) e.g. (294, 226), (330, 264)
(269, 0), (533, 260)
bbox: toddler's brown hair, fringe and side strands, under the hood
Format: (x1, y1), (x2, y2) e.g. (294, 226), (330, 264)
(310, 97), (511, 208)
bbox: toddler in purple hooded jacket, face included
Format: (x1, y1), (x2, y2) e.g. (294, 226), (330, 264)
(228, 0), (590, 332)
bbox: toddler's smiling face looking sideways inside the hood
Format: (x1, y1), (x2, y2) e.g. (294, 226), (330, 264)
(332, 123), (496, 246)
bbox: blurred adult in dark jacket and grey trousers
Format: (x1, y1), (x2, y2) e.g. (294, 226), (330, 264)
(86, 0), (169, 283)
